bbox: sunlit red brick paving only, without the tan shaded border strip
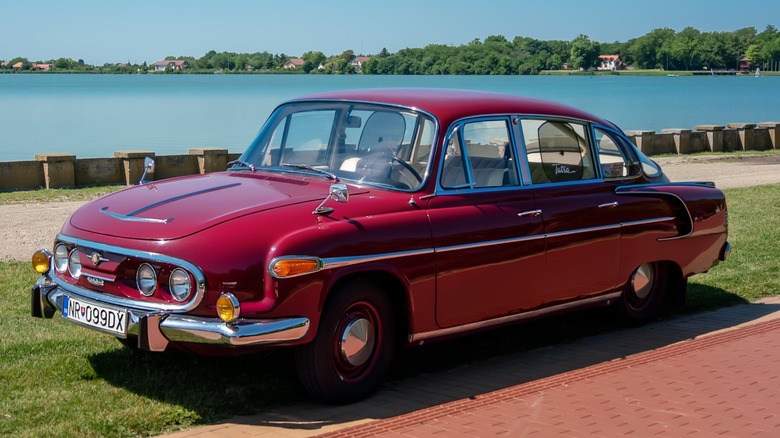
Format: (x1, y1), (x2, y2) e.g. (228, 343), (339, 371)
(324, 319), (780, 438)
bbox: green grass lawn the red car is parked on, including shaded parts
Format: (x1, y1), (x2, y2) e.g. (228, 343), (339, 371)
(0, 185), (780, 437)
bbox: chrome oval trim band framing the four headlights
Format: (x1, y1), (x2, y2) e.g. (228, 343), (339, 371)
(52, 234), (206, 312)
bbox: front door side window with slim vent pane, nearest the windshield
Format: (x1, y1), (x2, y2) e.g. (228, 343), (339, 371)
(441, 119), (519, 188)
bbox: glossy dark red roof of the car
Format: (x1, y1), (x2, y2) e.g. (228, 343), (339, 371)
(294, 88), (613, 126)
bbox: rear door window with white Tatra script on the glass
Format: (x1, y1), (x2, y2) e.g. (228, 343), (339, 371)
(521, 119), (597, 184)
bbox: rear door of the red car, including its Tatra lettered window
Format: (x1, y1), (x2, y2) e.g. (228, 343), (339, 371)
(520, 119), (622, 303)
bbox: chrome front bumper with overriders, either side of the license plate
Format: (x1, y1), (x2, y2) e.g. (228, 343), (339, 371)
(31, 276), (309, 351)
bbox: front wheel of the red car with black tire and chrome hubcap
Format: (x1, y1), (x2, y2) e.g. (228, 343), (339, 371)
(295, 280), (395, 404)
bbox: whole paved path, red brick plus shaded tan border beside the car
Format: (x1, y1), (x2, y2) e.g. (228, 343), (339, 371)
(165, 297), (780, 438)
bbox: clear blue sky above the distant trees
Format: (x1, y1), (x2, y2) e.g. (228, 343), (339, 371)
(0, 0), (780, 65)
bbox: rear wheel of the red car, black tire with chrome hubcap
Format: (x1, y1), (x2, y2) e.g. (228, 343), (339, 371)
(614, 262), (668, 325)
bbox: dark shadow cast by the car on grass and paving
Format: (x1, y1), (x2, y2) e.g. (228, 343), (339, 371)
(90, 284), (778, 433)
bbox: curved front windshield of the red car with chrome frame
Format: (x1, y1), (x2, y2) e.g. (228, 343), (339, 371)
(234, 102), (435, 190)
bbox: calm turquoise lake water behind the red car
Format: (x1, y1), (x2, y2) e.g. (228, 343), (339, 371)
(0, 74), (780, 161)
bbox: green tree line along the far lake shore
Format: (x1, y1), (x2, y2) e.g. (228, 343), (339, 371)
(1, 25), (780, 75)
